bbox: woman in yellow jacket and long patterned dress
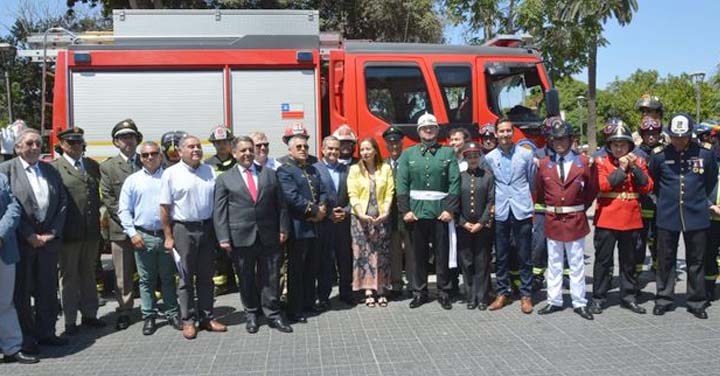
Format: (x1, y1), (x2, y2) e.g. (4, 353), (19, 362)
(347, 137), (395, 307)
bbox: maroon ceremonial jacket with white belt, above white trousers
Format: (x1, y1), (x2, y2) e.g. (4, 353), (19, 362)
(535, 152), (596, 242)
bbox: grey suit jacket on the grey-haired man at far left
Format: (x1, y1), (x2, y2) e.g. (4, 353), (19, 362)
(0, 157), (67, 245)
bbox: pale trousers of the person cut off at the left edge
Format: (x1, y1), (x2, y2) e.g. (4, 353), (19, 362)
(0, 260), (22, 355)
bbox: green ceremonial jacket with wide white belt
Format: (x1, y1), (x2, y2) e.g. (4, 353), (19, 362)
(395, 144), (460, 219)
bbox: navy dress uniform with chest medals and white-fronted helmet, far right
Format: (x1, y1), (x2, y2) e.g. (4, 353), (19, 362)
(650, 114), (718, 318)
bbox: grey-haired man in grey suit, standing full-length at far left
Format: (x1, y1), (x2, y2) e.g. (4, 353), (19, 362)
(0, 128), (67, 354)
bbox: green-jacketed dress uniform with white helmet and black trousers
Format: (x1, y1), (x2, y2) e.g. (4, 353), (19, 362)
(396, 114), (460, 309)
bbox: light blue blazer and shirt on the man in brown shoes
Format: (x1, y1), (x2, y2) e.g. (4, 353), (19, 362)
(485, 145), (537, 221)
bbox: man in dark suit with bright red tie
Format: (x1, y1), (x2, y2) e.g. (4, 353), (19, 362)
(213, 136), (292, 334)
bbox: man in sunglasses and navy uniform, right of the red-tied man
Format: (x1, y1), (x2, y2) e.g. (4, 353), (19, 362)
(277, 134), (327, 323)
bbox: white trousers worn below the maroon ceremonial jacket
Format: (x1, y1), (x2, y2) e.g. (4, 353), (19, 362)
(546, 237), (587, 308)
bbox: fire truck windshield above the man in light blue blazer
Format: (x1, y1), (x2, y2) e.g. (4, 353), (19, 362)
(487, 66), (544, 128)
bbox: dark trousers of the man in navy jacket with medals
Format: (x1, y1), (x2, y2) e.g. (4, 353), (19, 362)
(655, 227), (707, 309)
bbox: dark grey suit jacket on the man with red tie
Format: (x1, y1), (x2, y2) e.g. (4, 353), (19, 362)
(213, 165), (290, 250)
